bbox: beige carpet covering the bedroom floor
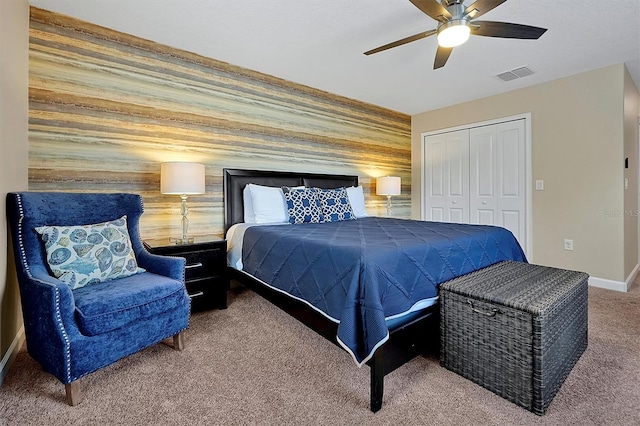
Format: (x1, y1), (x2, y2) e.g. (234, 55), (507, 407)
(0, 283), (640, 425)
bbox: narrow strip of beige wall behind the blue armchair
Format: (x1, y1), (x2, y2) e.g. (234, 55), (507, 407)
(0, 0), (29, 384)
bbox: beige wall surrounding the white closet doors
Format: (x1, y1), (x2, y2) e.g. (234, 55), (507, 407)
(411, 64), (638, 282)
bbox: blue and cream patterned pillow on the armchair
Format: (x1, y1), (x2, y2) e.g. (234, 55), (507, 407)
(36, 215), (145, 289)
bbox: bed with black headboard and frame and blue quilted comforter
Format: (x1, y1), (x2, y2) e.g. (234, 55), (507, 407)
(224, 169), (526, 412)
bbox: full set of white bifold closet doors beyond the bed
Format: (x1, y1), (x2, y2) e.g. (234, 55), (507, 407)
(424, 120), (526, 247)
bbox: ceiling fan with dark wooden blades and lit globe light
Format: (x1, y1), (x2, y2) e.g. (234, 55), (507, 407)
(364, 0), (547, 70)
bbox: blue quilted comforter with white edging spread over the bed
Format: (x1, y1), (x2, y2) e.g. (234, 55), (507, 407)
(242, 217), (526, 365)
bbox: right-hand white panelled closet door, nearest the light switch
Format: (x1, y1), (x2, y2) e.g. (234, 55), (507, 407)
(469, 120), (526, 247)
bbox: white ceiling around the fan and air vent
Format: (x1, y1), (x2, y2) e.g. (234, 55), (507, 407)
(29, 0), (640, 114)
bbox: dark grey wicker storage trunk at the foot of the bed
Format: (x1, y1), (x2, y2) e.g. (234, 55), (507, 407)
(440, 261), (589, 415)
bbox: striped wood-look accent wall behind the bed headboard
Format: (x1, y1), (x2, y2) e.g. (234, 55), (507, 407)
(29, 7), (411, 239)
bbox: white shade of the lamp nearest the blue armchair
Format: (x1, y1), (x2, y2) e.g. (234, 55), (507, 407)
(160, 161), (204, 195)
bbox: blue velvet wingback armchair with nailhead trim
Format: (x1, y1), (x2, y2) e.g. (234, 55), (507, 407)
(7, 192), (190, 405)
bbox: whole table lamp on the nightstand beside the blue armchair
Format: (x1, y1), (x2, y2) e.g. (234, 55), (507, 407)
(160, 161), (204, 244)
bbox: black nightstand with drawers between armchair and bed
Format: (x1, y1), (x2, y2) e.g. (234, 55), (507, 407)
(149, 238), (229, 312)
